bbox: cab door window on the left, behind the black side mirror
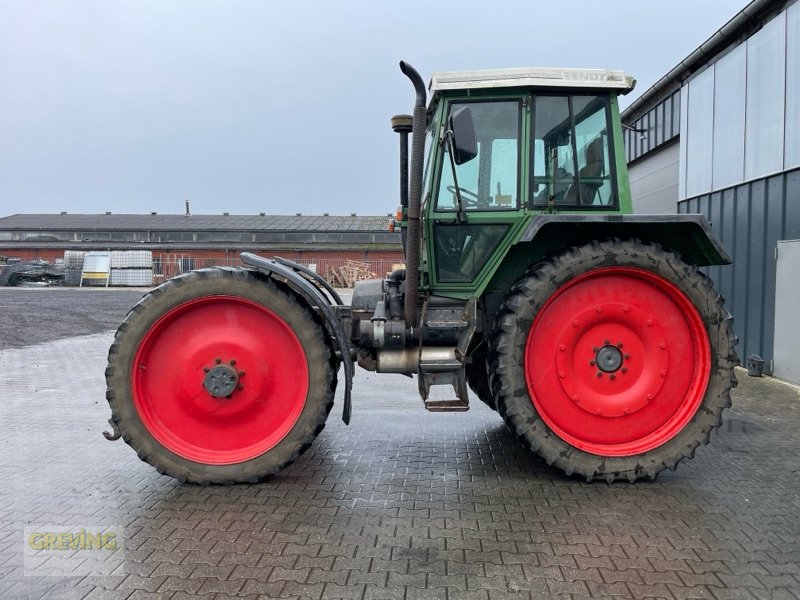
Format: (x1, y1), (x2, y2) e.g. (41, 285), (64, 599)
(436, 100), (520, 211)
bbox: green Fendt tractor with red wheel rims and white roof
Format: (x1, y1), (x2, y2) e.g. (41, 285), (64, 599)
(106, 62), (737, 484)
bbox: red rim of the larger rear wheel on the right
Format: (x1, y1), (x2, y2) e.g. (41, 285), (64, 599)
(525, 267), (711, 456)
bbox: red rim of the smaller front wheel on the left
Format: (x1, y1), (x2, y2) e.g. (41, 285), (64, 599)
(132, 296), (308, 465)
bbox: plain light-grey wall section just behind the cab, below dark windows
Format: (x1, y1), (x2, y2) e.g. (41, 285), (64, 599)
(628, 144), (679, 214)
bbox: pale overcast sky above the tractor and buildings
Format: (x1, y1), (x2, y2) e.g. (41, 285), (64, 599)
(0, 0), (747, 216)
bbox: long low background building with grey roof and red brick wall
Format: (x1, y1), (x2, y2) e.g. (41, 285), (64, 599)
(0, 213), (403, 283)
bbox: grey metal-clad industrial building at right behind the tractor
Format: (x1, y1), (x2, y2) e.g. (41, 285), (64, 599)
(622, 0), (800, 382)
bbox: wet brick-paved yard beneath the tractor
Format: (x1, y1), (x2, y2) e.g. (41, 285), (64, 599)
(0, 290), (800, 600)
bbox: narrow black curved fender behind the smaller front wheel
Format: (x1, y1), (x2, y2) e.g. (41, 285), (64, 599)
(236, 252), (355, 425)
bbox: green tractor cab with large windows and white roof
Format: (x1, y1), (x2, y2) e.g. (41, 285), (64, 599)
(410, 69), (634, 294)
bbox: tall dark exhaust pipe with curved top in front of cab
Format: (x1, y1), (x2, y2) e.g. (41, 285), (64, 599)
(400, 60), (427, 328)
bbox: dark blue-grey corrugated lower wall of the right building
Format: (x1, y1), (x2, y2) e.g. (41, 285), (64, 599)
(678, 169), (800, 369)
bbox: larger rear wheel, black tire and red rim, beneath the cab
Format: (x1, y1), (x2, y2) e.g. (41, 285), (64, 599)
(489, 241), (737, 482)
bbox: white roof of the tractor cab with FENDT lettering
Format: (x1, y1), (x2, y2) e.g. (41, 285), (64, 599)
(428, 67), (636, 96)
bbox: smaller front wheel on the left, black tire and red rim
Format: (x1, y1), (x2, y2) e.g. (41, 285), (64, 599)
(106, 268), (336, 484)
